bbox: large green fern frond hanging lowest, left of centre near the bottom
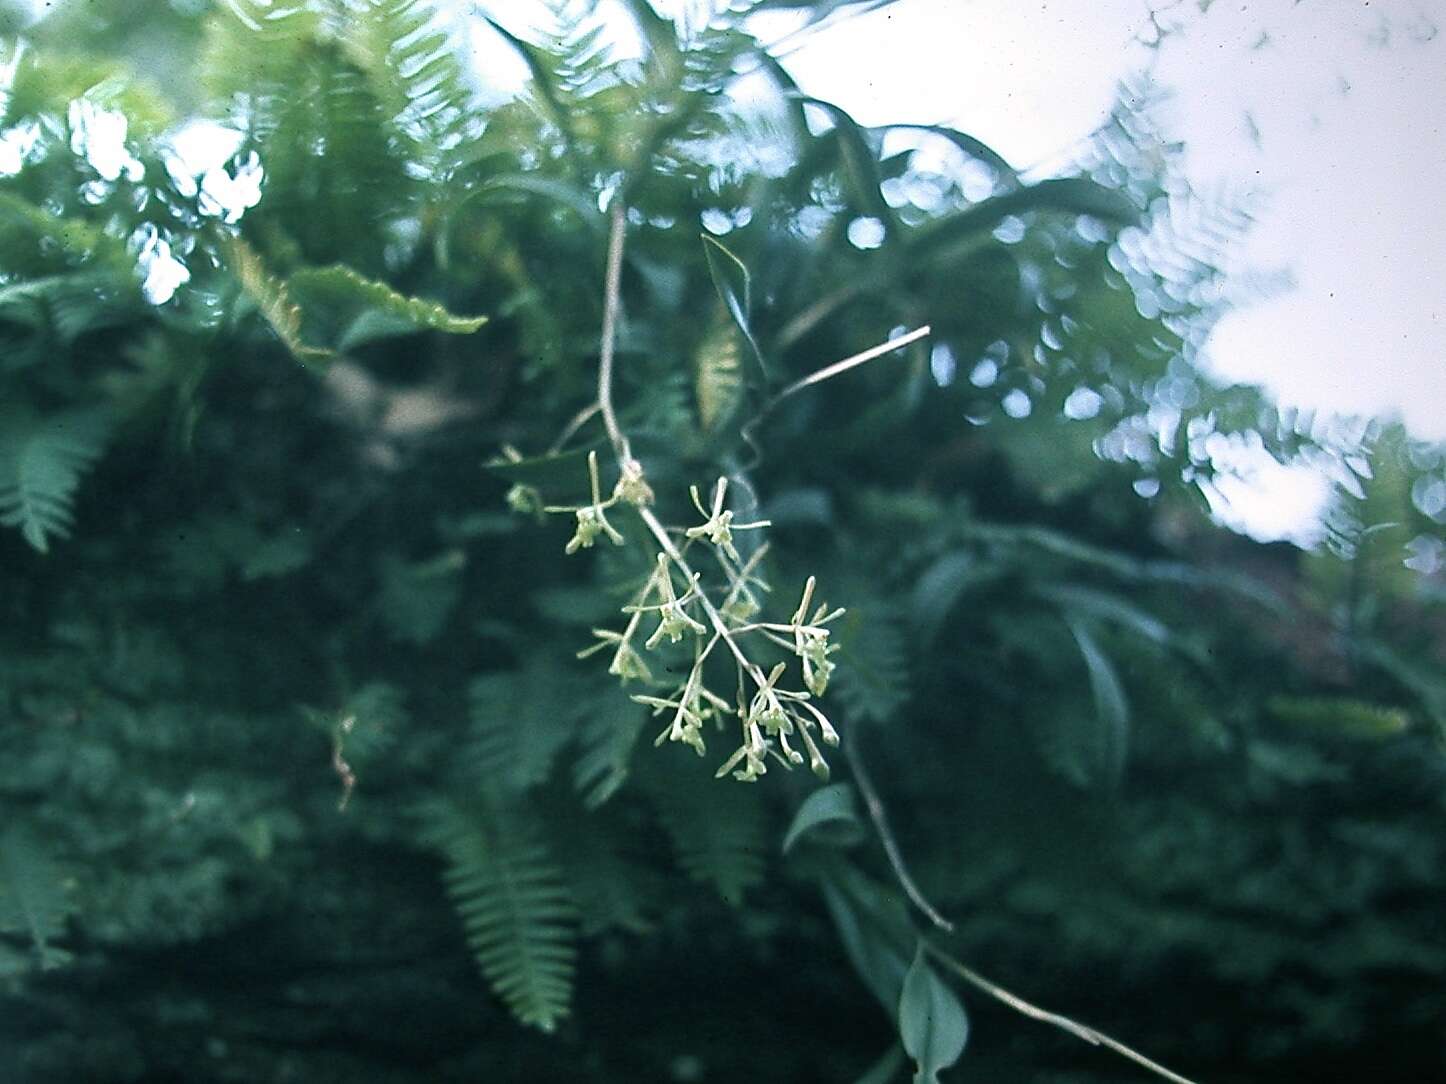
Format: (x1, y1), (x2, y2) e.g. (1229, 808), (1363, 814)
(429, 804), (577, 1032)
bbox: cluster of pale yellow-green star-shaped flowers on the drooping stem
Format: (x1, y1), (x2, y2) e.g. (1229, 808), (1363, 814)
(526, 454), (843, 782)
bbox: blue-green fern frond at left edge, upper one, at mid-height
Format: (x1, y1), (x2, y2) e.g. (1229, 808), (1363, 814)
(0, 408), (110, 554)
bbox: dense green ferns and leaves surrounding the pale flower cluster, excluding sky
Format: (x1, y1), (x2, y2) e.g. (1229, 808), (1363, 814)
(0, 0), (1446, 1083)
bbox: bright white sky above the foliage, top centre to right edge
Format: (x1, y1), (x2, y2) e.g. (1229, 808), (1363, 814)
(762, 0), (1446, 439)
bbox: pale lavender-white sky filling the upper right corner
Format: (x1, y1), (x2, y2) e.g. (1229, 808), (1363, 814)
(1161, 4), (1446, 439)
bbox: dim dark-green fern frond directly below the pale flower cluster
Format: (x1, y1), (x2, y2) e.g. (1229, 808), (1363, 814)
(646, 776), (766, 906)
